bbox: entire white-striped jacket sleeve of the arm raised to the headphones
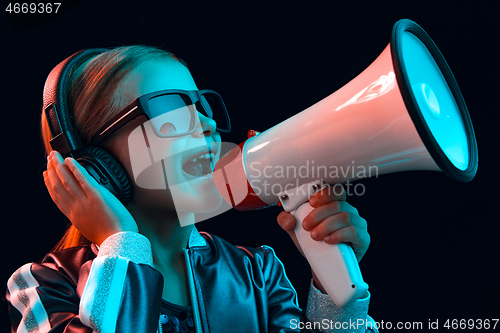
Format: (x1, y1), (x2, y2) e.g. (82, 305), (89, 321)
(7, 232), (163, 333)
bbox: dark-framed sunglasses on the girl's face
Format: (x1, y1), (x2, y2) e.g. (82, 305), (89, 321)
(91, 89), (231, 145)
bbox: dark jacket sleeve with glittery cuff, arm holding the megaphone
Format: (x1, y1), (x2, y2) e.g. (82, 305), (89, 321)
(262, 246), (378, 333)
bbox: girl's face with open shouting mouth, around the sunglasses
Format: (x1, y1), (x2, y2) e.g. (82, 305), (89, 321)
(113, 57), (226, 220)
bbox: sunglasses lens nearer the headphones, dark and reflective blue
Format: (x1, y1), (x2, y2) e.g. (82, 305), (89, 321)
(148, 94), (194, 136)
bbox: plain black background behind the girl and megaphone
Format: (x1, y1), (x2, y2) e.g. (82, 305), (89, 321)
(0, 0), (500, 330)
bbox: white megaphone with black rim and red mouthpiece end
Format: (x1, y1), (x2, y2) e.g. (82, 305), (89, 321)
(214, 19), (478, 307)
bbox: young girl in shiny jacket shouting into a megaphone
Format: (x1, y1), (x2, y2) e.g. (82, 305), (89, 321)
(7, 46), (376, 332)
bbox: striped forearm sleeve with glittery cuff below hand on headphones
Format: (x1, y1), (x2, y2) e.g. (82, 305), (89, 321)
(79, 232), (163, 333)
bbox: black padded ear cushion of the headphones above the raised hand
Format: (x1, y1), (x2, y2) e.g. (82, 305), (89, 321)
(77, 146), (132, 204)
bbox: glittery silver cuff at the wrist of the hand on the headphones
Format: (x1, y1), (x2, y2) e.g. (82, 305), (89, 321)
(98, 232), (153, 266)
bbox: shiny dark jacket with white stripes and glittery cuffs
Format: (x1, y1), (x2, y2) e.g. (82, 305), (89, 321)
(7, 228), (376, 333)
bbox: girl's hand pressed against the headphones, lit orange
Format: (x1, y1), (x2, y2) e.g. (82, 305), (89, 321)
(43, 151), (138, 245)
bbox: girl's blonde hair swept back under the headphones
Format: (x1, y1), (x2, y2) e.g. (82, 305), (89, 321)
(41, 45), (180, 250)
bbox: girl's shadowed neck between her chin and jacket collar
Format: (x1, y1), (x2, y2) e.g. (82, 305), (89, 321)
(127, 201), (194, 269)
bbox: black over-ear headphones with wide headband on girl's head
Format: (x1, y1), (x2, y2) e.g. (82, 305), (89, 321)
(43, 48), (132, 205)
